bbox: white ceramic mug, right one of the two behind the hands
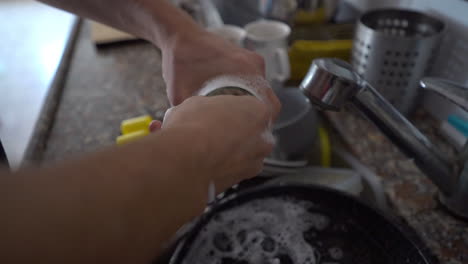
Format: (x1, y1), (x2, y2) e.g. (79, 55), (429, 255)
(244, 20), (291, 83)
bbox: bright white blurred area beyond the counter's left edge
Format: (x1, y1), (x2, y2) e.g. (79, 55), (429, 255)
(0, 0), (77, 166)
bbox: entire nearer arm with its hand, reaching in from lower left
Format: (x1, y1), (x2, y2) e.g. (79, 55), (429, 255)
(0, 96), (272, 264)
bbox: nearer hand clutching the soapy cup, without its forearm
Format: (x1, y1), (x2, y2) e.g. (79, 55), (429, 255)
(160, 96), (273, 191)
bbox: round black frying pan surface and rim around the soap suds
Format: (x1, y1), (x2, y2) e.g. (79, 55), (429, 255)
(170, 185), (436, 264)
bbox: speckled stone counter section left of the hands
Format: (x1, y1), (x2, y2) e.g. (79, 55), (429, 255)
(31, 23), (169, 162)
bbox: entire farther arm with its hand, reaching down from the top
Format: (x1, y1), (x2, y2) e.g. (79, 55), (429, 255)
(40, 0), (280, 108)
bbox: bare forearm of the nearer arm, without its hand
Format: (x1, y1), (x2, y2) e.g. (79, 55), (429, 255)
(0, 131), (207, 263)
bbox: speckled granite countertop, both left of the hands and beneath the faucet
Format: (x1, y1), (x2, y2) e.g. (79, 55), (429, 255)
(29, 23), (468, 264)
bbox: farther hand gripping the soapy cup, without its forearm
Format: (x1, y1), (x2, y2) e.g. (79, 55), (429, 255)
(162, 29), (280, 117)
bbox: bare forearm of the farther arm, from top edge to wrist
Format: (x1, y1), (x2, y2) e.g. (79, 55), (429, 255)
(40, 0), (202, 48)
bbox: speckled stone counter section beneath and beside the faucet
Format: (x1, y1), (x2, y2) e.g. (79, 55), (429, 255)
(327, 111), (468, 264)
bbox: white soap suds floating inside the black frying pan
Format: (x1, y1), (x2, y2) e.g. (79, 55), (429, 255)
(183, 197), (343, 264)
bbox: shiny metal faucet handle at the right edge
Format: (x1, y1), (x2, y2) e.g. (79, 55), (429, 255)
(420, 77), (468, 111)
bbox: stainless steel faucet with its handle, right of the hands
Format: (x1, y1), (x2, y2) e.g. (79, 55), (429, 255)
(300, 58), (468, 219)
